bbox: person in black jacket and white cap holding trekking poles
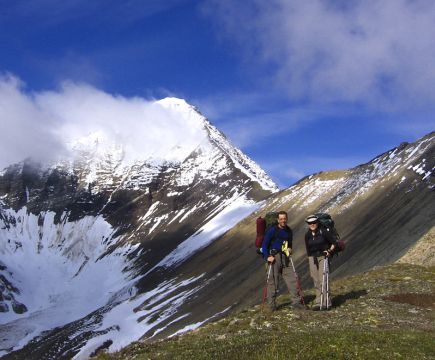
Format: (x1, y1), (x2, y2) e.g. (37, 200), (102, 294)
(305, 215), (336, 310)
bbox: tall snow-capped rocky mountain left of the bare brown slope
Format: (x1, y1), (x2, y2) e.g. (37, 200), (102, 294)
(0, 98), (277, 359)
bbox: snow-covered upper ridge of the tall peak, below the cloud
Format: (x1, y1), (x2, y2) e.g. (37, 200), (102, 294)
(45, 98), (278, 192)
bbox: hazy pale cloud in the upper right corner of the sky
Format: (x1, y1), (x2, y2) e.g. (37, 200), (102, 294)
(206, 0), (435, 110)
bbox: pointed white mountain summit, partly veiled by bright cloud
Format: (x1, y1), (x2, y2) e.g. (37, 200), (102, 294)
(55, 97), (277, 191)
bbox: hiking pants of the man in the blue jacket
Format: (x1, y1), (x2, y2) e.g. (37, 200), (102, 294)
(267, 253), (299, 307)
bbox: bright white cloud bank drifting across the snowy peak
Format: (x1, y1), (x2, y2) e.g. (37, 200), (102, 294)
(0, 76), (206, 168)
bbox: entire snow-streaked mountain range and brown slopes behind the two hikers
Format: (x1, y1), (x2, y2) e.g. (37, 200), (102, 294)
(0, 98), (435, 359)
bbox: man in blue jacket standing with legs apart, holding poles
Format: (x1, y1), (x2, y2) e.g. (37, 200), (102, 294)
(262, 211), (304, 311)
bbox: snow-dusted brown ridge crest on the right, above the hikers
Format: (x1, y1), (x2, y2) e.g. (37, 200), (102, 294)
(274, 135), (435, 212)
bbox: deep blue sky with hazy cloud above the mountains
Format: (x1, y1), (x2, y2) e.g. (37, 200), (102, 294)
(0, 0), (435, 187)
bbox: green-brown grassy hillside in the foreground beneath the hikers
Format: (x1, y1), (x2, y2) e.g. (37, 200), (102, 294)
(97, 264), (435, 360)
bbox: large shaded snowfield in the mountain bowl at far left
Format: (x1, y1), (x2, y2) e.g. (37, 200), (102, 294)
(0, 208), (134, 355)
